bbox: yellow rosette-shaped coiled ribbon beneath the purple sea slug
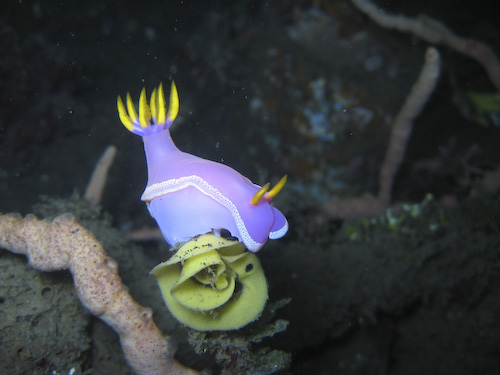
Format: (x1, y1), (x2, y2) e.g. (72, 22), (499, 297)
(151, 234), (267, 331)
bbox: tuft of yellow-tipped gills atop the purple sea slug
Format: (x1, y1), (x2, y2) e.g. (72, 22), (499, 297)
(117, 81), (179, 136)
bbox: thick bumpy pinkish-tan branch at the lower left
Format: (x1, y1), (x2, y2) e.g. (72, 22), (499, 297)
(0, 214), (198, 375)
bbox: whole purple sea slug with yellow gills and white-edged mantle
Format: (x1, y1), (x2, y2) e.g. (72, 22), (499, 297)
(118, 82), (288, 252)
